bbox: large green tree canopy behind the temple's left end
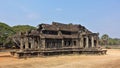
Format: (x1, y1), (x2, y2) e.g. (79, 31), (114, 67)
(0, 22), (36, 47)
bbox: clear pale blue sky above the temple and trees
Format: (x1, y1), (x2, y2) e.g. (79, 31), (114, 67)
(0, 0), (120, 38)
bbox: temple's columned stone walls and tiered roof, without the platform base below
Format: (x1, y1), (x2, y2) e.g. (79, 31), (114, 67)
(20, 22), (99, 49)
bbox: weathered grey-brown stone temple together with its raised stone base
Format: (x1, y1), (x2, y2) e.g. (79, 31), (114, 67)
(10, 22), (106, 55)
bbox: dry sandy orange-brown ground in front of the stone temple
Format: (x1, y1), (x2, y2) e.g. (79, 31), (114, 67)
(0, 49), (120, 68)
